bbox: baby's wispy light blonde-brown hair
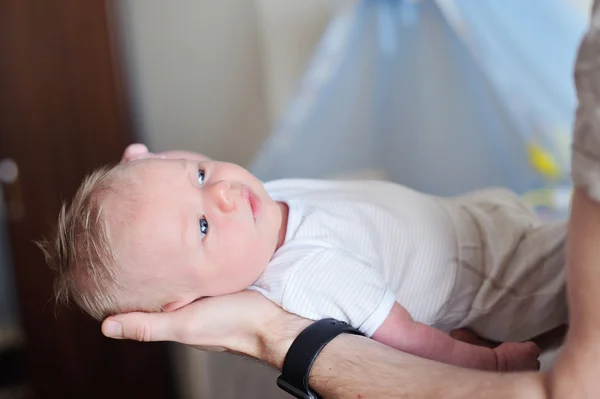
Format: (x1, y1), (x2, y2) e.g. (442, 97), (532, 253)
(38, 166), (154, 320)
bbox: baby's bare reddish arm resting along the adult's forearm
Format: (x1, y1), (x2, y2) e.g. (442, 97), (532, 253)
(372, 303), (540, 371)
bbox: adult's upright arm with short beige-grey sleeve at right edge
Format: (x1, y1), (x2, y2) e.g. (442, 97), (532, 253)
(550, 0), (600, 397)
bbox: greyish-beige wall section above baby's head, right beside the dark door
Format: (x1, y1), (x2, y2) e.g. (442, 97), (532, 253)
(119, 0), (267, 163)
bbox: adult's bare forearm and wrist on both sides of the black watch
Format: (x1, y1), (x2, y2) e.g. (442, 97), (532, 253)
(256, 316), (548, 399)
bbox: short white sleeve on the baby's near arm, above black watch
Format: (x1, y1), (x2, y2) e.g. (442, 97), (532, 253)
(281, 248), (395, 337)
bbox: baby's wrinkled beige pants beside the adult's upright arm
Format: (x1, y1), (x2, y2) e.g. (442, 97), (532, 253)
(444, 189), (568, 341)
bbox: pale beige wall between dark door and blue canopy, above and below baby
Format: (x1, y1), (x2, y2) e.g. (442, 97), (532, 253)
(116, 0), (330, 399)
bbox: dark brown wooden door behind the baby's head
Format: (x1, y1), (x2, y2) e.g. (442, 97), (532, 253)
(0, 0), (176, 399)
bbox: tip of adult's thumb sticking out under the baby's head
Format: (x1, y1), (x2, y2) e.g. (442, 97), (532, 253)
(102, 312), (174, 342)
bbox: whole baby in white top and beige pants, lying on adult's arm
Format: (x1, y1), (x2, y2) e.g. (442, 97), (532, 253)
(42, 144), (568, 370)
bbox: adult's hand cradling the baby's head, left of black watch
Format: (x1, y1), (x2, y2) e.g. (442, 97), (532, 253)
(102, 291), (310, 367)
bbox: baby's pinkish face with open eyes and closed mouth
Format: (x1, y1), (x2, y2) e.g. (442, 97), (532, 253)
(106, 158), (285, 310)
